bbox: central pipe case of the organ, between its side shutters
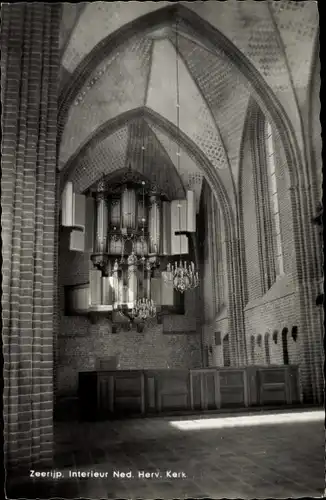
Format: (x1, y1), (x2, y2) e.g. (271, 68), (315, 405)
(91, 168), (162, 321)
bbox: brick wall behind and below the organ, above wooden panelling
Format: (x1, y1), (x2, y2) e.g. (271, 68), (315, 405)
(56, 238), (201, 397)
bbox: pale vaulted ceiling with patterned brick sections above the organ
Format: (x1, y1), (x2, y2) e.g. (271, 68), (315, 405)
(59, 0), (318, 213)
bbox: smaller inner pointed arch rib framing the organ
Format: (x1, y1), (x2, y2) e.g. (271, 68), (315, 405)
(58, 107), (246, 364)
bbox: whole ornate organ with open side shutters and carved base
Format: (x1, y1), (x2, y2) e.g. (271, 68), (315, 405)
(61, 167), (198, 328)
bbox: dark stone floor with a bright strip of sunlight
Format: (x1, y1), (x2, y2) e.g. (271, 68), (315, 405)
(6, 409), (325, 500)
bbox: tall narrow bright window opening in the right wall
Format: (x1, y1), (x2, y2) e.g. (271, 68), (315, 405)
(266, 122), (284, 276)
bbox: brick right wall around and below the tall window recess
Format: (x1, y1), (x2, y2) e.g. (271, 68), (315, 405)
(240, 106), (304, 376)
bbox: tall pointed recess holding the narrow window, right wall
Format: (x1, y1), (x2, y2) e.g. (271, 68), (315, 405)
(239, 100), (288, 301)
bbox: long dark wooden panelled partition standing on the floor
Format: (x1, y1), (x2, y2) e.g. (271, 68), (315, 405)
(79, 365), (300, 419)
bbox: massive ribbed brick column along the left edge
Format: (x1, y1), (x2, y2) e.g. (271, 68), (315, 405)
(1, 2), (60, 471)
